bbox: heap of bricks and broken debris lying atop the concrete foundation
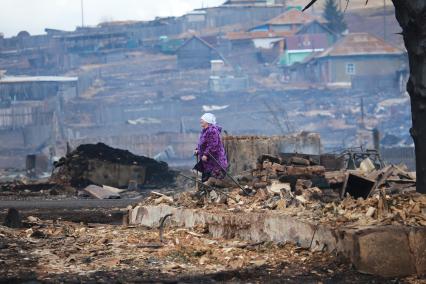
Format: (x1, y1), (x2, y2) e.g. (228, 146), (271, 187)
(140, 155), (426, 226)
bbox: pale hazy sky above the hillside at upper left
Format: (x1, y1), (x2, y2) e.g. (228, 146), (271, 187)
(0, 0), (225, 37)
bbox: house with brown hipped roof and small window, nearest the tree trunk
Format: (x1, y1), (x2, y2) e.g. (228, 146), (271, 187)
(306, 33), (405, 87)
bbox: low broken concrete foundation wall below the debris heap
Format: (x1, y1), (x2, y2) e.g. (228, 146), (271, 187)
(129, 205), (426, 277)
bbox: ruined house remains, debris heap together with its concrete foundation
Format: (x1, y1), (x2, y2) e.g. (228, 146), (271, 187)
(128, 151), (426, 277)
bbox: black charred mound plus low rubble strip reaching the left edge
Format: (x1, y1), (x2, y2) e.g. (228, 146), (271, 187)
(0, 143), (180, 202)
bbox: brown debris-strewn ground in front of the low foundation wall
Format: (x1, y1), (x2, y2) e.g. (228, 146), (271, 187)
(0, 217), (392, 283)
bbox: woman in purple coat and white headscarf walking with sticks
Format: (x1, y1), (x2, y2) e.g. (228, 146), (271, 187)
(195, 113), (228, 182)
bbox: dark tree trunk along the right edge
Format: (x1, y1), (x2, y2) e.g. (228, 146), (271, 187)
(392, 0), (426, 194)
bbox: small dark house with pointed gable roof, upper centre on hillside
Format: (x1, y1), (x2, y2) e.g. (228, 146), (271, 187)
(176, 36), (225, 69)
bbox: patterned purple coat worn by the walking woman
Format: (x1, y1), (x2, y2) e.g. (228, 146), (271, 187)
(197, 124), (228, 179)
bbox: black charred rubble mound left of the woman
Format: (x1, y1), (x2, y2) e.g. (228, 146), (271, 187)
(52, 143), (176, 188)
